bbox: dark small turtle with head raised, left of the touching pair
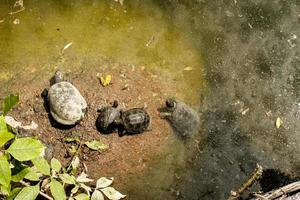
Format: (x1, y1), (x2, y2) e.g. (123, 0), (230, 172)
(96, 101), (121, 133)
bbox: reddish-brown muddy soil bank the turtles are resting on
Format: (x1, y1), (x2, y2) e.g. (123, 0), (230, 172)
(9, 64), (177, 189)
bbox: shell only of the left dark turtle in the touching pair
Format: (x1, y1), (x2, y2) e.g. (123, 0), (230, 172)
(96, 106), (120, 133)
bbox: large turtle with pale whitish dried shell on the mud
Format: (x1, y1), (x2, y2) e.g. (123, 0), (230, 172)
(42, 70), (87, 125)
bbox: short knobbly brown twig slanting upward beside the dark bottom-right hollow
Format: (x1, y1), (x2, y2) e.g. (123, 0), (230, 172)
(227, 164), (263, 200)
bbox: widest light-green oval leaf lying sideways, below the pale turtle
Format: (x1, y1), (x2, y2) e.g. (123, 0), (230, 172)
(7, 138), (45, 161)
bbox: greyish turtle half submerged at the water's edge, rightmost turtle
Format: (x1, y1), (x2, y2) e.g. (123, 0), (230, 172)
(160, 98), (200, 137)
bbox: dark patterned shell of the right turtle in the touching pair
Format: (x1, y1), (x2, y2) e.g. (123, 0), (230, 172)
(121, 108), (150, 134)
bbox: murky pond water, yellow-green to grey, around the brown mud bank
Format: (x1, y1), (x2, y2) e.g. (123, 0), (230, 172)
(0, 0), (300, 200)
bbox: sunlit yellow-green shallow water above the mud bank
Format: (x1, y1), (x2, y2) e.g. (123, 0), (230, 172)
(0, 1), (202, 101)
